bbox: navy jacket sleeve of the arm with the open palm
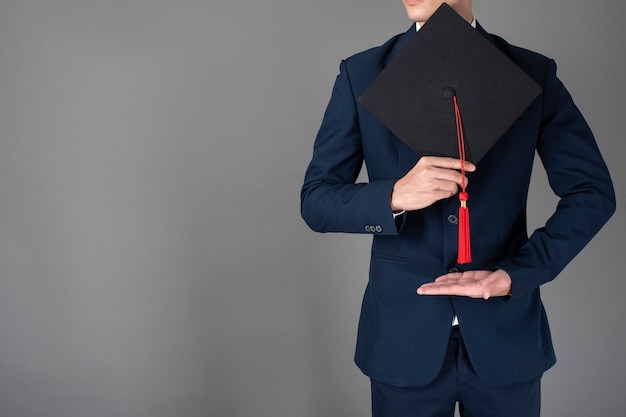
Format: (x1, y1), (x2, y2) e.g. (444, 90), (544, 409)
(499, 60), (615, 297)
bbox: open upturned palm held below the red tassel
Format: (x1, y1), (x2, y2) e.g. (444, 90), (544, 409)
(417, 269), (511, 300)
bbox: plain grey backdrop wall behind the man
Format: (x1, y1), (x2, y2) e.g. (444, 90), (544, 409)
(0, 0), (626, 417)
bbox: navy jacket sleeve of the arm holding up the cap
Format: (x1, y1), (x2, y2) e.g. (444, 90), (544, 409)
(301, 61), (398, 235)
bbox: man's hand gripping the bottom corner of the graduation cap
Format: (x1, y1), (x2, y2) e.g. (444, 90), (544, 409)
(391, 156), (476, 211)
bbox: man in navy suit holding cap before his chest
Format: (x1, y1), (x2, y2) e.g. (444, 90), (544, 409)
(301, 0), (615, 417)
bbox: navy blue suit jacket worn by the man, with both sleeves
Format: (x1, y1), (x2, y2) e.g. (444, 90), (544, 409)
(301, 26), (615, 386)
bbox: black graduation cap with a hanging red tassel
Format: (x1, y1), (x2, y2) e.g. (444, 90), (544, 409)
(359, 3), (541, 263)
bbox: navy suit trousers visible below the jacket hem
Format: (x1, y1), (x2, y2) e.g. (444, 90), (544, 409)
(371, 326), (541, 417)
